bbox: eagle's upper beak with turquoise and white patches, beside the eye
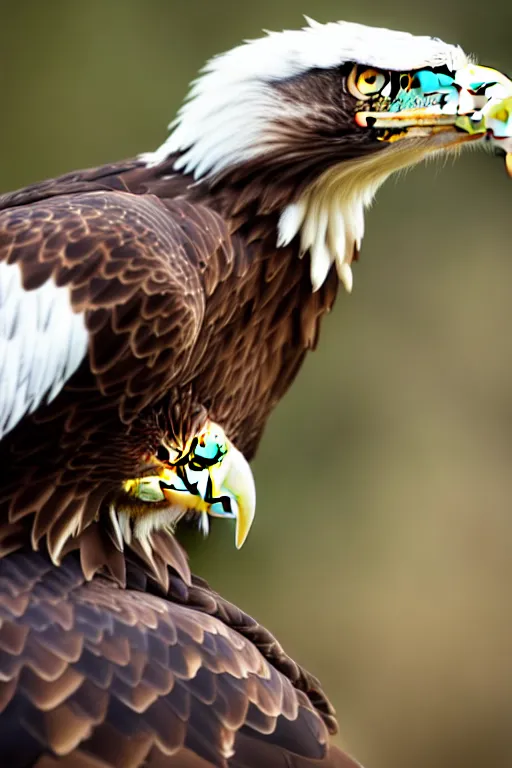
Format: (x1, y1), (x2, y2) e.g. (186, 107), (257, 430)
(356, 64), (512, 149)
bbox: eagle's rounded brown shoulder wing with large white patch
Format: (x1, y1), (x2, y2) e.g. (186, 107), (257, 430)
(0, 191), (212, 439)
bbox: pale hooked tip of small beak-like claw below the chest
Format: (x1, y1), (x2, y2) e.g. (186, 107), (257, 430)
(209, 443), (256, 549)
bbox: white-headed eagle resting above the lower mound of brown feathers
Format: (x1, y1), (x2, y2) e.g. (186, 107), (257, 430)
(0, 22), (512, 583)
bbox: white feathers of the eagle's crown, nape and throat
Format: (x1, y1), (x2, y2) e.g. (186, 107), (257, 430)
(142, 19), (468, 290)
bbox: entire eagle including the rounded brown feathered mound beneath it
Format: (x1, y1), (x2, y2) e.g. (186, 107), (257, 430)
(0, 19), (512, 768)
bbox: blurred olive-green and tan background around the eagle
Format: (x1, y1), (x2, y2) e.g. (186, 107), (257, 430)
(0, 0), (512, 768)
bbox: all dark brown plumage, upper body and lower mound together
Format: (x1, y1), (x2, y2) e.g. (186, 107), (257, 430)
(0, 161), (344, 768)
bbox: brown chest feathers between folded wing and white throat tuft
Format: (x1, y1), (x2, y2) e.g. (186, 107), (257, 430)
(184, 204), (337, 457)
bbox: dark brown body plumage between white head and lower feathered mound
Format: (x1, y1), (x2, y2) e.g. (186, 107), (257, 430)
(0, 161), (336, 581)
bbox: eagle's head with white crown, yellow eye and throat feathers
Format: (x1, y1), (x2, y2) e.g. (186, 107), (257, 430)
(143, 19), (512, 292)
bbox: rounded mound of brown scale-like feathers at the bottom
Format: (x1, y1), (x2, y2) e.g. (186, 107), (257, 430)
(0, 552), (357, 768)
